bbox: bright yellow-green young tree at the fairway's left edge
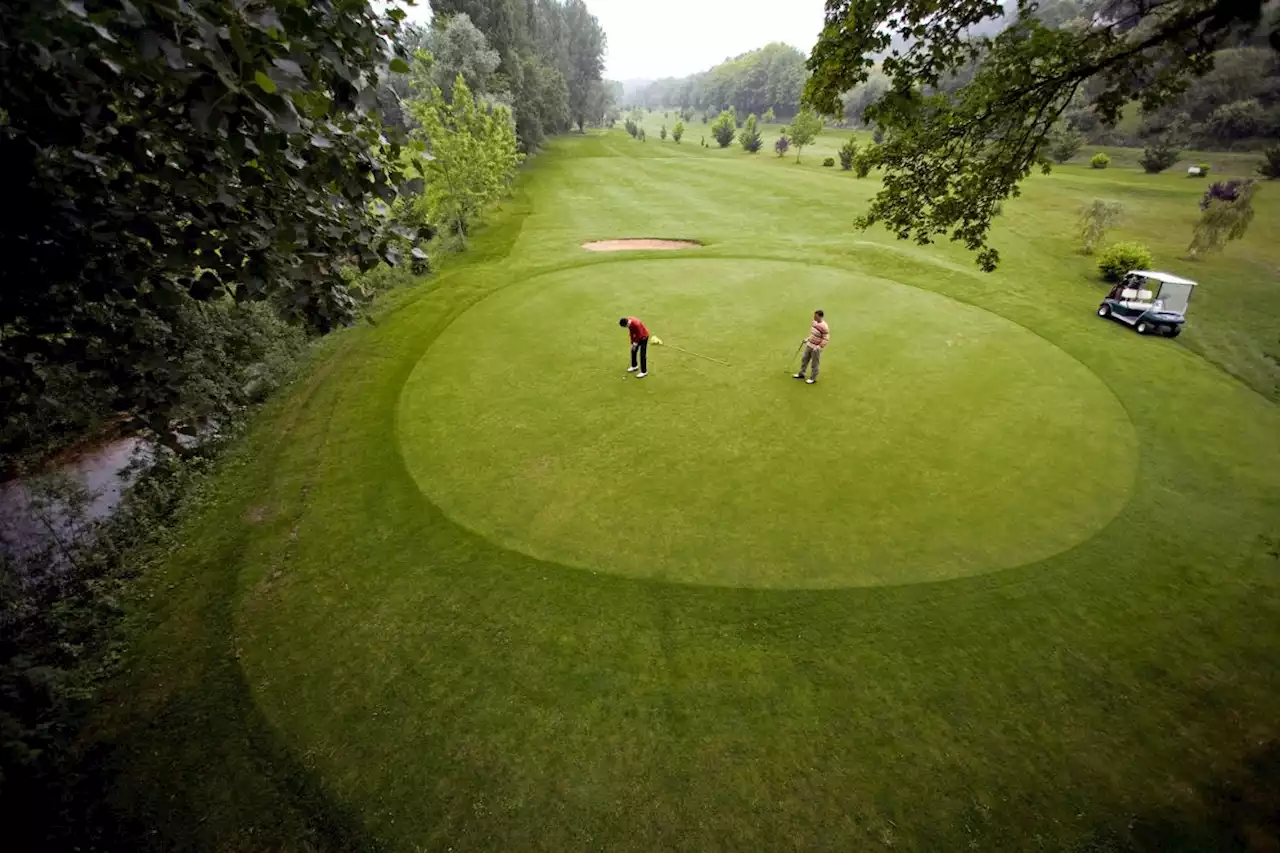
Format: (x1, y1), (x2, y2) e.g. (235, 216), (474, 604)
(411, 74), (521, 243)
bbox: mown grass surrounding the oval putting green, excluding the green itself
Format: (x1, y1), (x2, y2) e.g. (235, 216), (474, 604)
(92, 131), (1280, 850)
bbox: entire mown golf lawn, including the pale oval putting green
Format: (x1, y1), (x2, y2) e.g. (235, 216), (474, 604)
(92, 132), (1280, 850)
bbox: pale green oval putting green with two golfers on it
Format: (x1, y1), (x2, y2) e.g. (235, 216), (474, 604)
(399, 259), (1137, 588)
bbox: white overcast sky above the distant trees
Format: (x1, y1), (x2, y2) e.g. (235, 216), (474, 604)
(410, 0), (823, 79)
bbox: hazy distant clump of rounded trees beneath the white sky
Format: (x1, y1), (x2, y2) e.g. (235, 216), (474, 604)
(631, 42), (808, 120)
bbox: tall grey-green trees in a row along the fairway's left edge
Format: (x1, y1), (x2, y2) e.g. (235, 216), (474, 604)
(424, 0), (616, 151)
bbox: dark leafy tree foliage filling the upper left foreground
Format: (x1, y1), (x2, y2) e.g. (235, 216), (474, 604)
(0, 0), (426, 448)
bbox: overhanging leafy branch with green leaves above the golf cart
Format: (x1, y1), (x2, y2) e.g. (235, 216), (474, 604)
(805, 0), (1280, 270)
